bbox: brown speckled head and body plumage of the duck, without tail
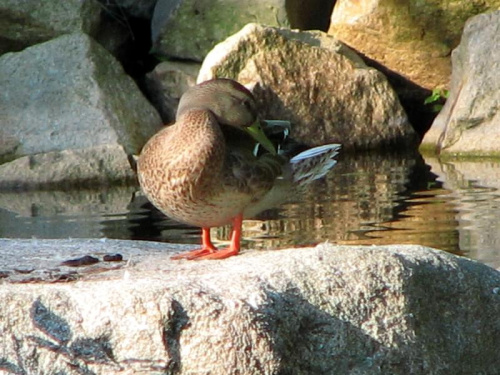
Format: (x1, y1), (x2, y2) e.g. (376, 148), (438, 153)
(138, 80), (282, 232)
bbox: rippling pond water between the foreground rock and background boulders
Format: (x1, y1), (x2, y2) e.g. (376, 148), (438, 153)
(0, 154), (500, 268)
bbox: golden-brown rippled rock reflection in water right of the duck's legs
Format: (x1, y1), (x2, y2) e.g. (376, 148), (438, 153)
(214, 154), (456, 251)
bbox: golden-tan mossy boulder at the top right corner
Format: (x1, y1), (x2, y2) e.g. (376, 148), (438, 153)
(328, 0), (500, 90)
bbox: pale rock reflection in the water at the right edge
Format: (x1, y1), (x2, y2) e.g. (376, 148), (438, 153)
(425, 157), (500, 267)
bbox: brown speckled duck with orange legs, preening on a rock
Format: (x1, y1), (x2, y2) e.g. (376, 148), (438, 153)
(137, 78), (340, 260)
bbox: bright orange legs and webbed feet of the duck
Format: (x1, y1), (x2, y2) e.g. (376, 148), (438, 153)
(171, 214), (243, 260)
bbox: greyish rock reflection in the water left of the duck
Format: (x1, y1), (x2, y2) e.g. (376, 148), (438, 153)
(0, 187), (136, 238)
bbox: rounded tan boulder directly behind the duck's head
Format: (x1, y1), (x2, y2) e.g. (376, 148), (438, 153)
(198, 24), (416, 150)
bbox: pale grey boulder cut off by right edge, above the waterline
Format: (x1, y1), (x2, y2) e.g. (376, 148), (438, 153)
(421, 11), (500, 156)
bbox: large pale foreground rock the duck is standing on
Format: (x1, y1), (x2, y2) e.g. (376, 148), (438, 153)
(0, 240), (500, 375)
